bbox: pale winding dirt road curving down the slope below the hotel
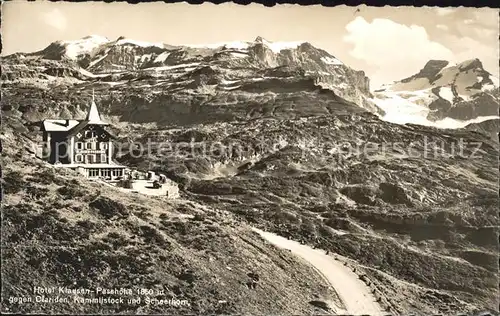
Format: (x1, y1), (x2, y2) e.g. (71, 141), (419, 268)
(253, 228), (388, 316)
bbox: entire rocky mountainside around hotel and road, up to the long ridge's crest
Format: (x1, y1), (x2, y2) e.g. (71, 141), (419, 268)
(2, 37), (499, 314)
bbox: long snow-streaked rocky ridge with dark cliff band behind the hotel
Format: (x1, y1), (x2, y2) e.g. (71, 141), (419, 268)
(2, 36), (380, 123)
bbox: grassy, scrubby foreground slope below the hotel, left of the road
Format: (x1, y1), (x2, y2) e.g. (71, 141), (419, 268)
(2, 151), (338, 314)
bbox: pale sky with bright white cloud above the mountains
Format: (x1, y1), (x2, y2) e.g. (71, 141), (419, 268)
(1, 1), (499, 89)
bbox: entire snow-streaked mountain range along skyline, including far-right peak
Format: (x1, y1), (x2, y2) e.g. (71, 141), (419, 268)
(2, 35), (498, 128)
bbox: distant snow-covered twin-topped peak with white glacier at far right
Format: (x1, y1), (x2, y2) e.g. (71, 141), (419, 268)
(374, 59), (499, 127)
